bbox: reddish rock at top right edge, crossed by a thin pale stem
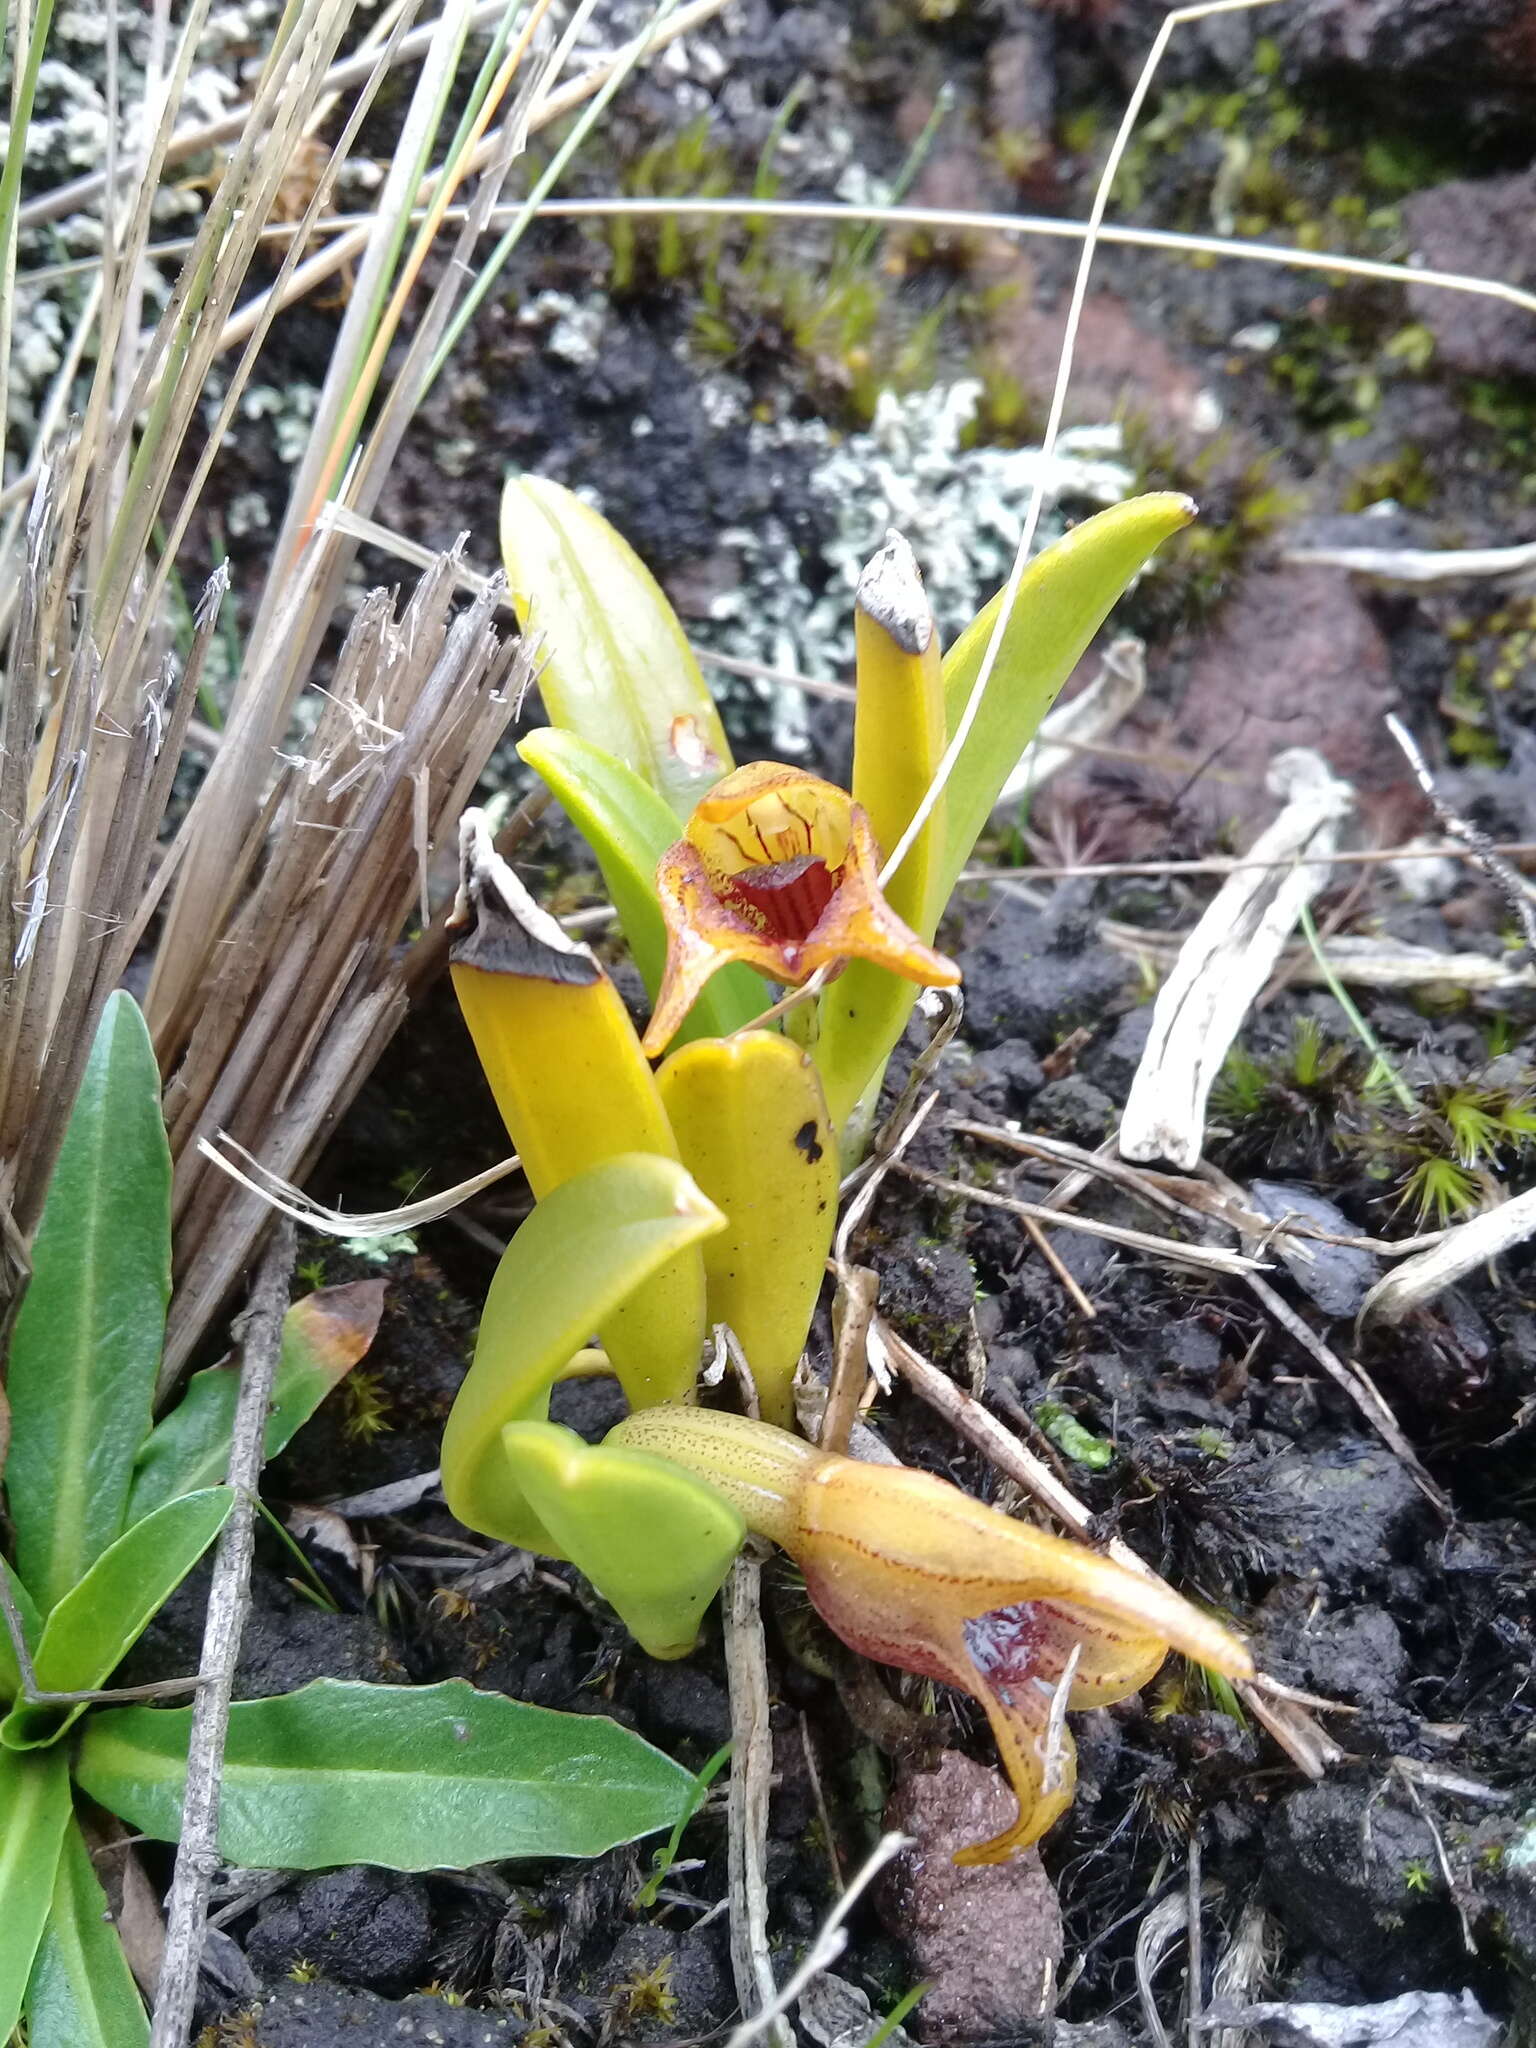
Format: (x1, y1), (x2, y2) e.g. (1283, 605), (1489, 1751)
(1403, 170), (1536, 377)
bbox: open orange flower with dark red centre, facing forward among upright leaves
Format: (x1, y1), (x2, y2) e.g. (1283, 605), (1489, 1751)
(645, 762), (961, 1057)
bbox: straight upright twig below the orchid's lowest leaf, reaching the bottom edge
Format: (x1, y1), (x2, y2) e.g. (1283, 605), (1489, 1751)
(723, 1554), (795, 2048)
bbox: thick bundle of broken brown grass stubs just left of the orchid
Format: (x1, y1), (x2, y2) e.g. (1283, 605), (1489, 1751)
(164, 555), (522, 1382)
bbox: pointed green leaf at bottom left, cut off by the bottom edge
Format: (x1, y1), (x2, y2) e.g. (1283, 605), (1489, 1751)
(27, 1823), (150, 2048)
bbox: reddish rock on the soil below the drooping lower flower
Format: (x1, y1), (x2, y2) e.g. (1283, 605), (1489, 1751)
(881, 1749), (1063, 2048)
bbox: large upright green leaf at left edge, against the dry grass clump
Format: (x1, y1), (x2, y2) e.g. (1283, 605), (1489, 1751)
(6, 991), (170, 1614)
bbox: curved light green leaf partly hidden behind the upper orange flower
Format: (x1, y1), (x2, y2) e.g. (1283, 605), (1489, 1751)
(518, 725), (772, 1044)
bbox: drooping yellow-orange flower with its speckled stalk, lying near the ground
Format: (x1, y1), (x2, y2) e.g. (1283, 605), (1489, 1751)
(610, 1407), (1253, 1864)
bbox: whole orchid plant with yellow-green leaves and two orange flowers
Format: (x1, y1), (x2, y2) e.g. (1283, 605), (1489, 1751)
(442, 479), (1251, 1860)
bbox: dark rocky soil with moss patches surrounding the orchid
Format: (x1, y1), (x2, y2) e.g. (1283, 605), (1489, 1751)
(135, 0), (1536, 2048)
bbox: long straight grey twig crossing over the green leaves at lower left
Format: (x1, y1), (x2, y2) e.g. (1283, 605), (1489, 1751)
(150, 1223), (297, 2048)
